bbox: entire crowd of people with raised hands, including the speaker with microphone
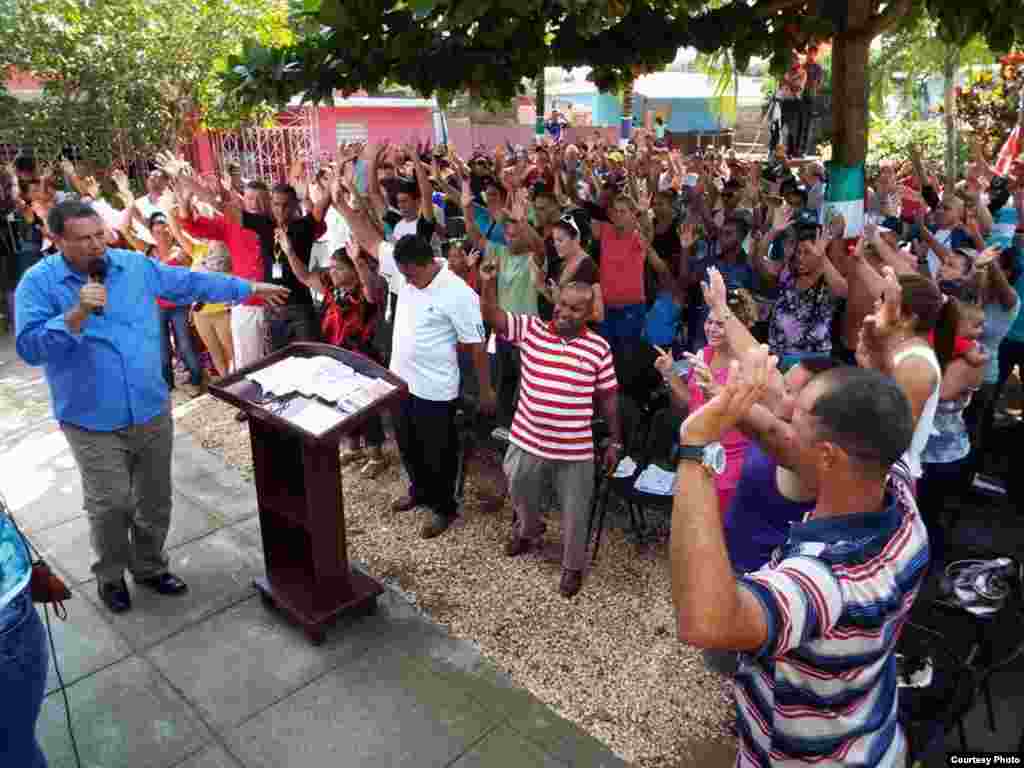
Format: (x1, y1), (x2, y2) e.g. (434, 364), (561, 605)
(0, 124), (1024, 765)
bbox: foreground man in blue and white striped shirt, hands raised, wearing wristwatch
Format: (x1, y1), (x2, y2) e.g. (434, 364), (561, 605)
(671, 356), (928, 768)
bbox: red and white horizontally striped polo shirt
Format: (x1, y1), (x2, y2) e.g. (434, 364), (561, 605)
(506, 312), (618, 461)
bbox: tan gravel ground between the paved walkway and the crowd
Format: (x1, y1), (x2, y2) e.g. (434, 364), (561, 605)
(174, 391), (732, 768)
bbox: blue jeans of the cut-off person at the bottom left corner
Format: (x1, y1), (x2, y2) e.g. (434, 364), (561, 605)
(0, 588), (49, 768)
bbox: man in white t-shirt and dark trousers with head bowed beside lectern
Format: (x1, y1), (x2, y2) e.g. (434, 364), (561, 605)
(377, 234), (496, 539)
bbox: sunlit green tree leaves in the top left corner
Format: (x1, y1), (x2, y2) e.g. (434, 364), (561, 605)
(0, 0), (296, 160)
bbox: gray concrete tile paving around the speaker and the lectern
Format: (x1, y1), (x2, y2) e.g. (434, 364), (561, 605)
(0, 337), (626, 768)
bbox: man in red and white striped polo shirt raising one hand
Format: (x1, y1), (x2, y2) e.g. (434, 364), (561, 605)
(480, 260), (623, 598)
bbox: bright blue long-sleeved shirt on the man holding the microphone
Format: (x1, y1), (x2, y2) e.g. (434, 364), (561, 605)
(14, 248), (251, 432)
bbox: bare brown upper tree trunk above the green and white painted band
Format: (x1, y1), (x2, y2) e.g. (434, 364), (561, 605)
(831, 0), (872, 166)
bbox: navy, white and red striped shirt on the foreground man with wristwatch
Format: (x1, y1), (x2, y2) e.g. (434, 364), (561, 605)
(735, 474), (929, 768)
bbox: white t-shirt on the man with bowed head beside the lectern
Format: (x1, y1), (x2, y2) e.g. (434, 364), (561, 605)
(391, 262), (483, 402)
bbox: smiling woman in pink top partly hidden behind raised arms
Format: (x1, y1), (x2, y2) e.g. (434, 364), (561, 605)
(654, 289), (758, 515)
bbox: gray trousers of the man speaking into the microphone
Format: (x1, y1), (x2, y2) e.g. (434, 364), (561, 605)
(60, 414), (174, 584)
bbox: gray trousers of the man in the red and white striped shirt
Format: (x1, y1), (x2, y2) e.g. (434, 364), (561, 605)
(504, 445), (594, 570)
